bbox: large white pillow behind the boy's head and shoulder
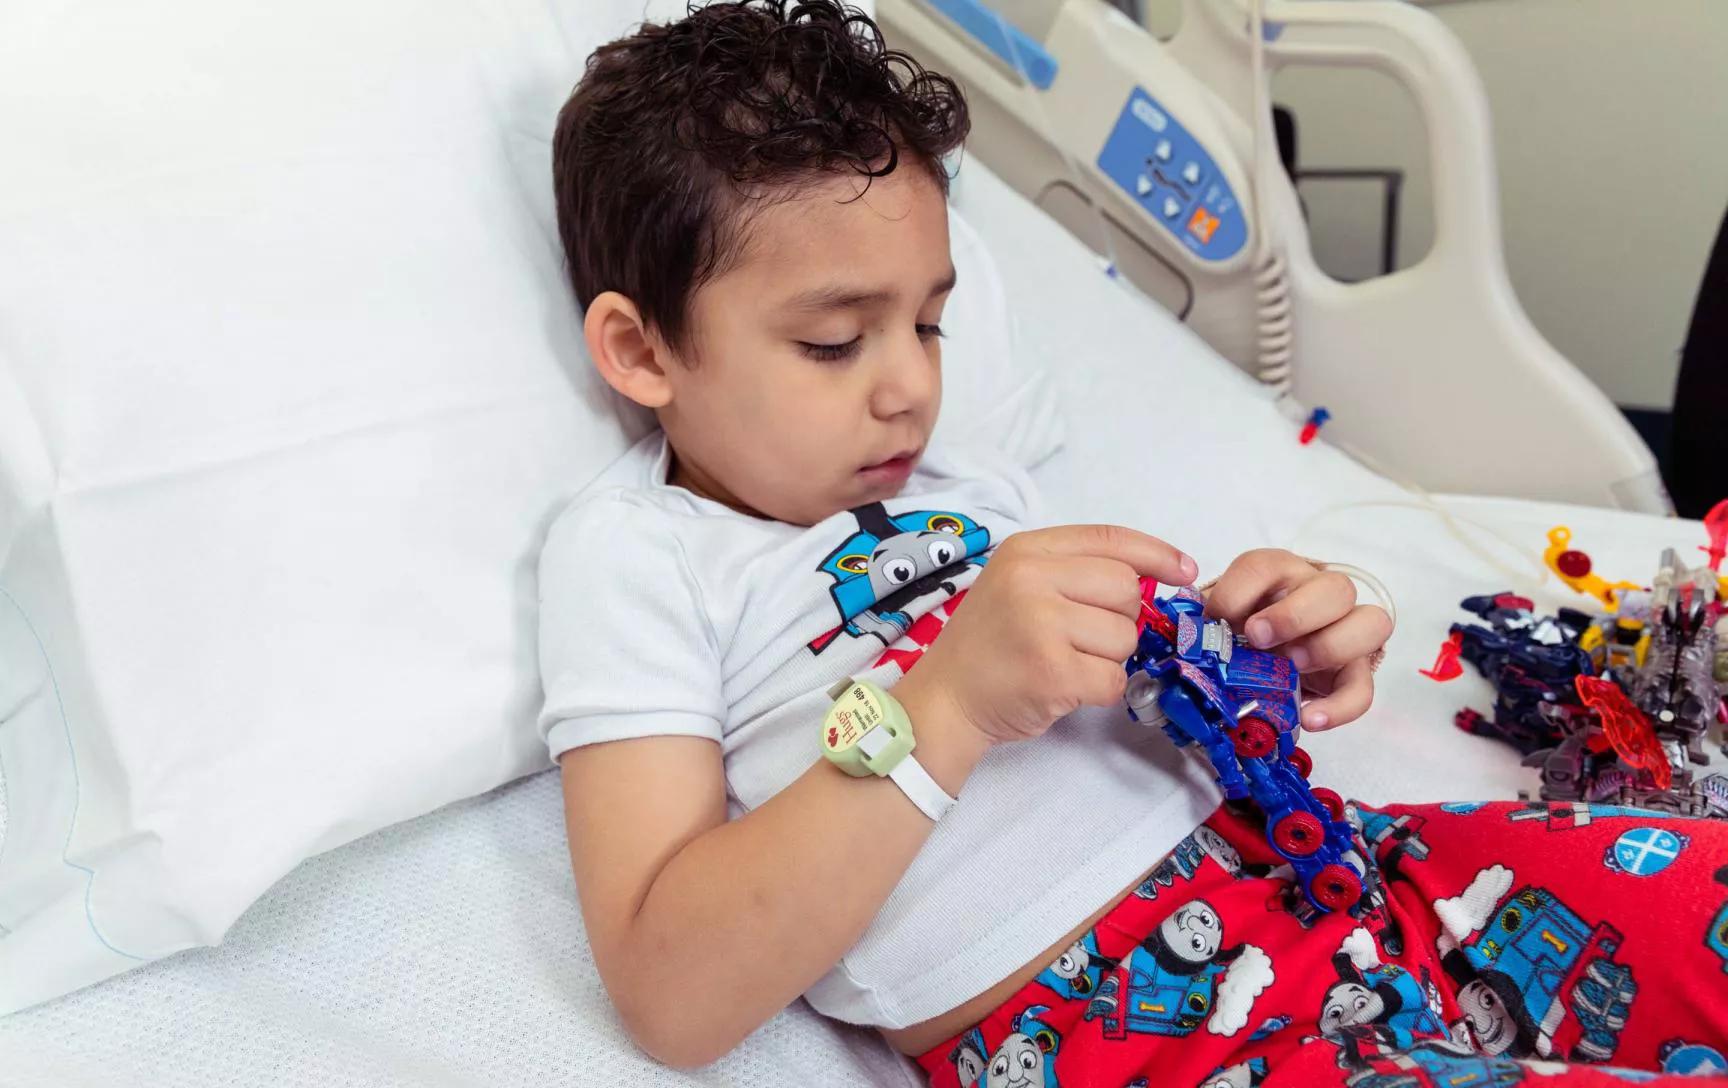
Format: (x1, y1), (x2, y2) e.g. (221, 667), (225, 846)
(0, 0), (1056, 1012)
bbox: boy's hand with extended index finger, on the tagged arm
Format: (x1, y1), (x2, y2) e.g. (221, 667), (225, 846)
(895, 525), (1198, 743)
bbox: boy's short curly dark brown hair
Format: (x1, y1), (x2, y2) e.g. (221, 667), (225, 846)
(553, 0), (968, 345)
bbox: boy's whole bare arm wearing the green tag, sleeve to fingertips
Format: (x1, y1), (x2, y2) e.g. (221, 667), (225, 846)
(562, 525), (1194, 1066)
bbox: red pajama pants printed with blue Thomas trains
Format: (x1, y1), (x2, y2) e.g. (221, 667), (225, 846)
(919, 803), (1728, 1088)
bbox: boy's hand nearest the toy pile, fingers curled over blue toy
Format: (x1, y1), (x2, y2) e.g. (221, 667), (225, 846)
(1206, 547), (1393, 729)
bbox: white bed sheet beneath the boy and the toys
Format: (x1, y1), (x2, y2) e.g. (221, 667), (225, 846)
(0, 162), (1702, 1088)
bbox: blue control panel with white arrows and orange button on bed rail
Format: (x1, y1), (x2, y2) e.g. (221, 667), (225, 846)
(1097, 86), (1248, 261)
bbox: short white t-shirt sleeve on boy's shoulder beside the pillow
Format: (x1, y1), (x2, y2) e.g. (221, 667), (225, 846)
(539, 494), (726, 762)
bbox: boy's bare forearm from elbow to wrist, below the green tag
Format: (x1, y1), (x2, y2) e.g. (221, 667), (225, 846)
(608, 680), (988, 1066)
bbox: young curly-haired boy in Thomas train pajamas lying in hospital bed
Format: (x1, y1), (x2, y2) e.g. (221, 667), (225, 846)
(541, 0), (1728, 1088)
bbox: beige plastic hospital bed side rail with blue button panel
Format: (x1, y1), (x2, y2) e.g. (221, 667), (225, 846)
(878, 0), (1669, 513)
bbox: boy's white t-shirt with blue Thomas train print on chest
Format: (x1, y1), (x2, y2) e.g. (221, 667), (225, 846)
(539, 432), (1218, 1028)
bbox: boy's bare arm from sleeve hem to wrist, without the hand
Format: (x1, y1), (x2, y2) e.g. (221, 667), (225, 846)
(562, 679), (988, 1066)
